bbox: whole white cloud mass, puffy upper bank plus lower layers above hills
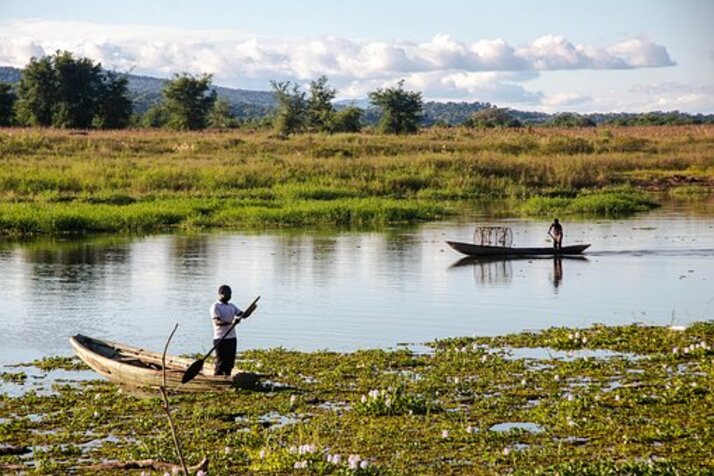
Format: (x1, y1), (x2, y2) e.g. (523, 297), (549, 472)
(0, 20), (696, 108)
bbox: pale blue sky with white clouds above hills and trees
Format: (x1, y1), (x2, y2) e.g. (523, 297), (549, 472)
(0, 0), (714, 114)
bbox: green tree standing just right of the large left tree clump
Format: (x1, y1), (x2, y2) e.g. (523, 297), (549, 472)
(163, 73), (216, 130)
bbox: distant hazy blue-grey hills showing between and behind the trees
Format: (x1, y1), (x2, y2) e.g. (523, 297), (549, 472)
(0, 66), (714, 126)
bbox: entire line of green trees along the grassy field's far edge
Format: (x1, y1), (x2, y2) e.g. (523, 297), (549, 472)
(0, 51), (714, 132)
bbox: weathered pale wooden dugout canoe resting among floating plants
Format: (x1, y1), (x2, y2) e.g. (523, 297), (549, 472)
(69, 334), (265, 392)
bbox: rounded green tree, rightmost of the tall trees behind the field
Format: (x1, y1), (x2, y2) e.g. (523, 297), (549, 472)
(369, 80), (423, 134)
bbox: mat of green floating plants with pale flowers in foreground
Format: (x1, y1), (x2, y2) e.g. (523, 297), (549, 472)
(0, 321), (714, 475)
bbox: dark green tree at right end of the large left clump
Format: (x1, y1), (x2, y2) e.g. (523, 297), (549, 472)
(94, 71), (132, 129)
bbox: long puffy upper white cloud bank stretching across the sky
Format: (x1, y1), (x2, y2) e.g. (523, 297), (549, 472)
(0, 20), (674, 78)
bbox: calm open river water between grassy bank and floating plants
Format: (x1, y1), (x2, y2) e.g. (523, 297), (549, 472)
(0, 204), (714, 364)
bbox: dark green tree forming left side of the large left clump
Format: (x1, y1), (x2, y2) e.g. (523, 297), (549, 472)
(17, 56), (58, 127)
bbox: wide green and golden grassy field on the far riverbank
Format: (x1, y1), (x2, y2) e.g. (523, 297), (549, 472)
(0, 126), (714, 235)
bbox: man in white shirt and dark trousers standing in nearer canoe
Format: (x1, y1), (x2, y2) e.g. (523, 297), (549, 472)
(210, 284), (243, 375)
